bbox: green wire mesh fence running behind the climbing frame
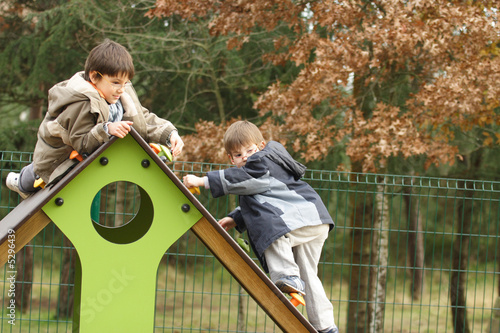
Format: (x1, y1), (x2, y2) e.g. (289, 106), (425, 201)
(0, 151), (500, 332)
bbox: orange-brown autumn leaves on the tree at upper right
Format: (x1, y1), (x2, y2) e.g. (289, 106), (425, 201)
(148, 0), (500, 171)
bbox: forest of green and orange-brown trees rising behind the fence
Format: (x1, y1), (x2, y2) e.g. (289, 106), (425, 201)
(0, 0), (500, 332)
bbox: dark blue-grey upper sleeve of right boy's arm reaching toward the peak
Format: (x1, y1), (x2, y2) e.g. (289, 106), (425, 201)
(207, 156), (271, 198)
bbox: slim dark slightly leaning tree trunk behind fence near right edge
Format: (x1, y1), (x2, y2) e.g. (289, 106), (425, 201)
(450, 181), (474, 333)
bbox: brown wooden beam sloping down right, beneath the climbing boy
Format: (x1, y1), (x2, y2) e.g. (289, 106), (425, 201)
(191, 217), (316, 333)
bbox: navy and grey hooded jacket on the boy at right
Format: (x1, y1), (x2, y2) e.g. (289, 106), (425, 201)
(207, 141), (334, 271)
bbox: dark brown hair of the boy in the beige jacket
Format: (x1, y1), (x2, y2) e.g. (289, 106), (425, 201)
(85, 39), (135, 81)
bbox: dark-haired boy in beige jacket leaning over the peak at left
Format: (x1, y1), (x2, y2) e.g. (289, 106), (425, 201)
(6, 39), (184, 198)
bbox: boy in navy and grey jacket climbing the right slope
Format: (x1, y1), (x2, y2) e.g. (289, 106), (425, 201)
(183, 121), (338, 333)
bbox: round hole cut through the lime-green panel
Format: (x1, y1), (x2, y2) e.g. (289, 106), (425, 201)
(90, 181), (153, 244)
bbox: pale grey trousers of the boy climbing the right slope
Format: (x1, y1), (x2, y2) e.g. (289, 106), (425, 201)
(264, 224), (335, 330)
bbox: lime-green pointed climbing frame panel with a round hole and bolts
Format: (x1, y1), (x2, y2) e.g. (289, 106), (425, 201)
(43, 135), (202, 333)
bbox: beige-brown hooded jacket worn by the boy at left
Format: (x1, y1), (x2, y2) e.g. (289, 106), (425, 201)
(33, 72), (175, 184)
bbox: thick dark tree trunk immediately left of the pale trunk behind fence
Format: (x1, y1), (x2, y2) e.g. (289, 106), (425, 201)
(347, 174), (373, 333)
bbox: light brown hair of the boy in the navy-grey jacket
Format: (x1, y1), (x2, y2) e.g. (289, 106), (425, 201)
(223, 120), (265, 155)
